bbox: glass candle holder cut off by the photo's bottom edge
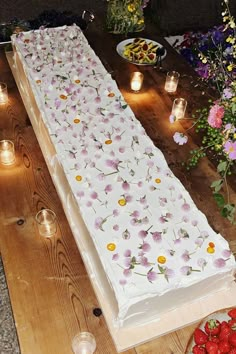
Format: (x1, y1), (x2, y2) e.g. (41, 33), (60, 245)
(72, 332), (96, 354)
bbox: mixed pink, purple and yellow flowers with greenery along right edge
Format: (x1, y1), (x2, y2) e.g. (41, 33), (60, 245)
(170, 0), (236, 223)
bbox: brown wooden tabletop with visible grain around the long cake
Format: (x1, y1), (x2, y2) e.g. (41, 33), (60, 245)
(0, 17), (236, 354)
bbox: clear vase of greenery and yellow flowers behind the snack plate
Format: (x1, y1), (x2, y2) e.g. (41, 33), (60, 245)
(106, 0), (144, 34)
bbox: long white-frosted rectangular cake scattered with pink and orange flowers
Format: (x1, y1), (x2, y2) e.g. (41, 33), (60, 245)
(12, 26), (235, 328)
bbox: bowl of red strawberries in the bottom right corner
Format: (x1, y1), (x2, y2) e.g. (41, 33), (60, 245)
(185, 308), (236, 354)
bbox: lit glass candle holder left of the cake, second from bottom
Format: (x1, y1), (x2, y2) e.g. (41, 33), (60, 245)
(35, 209), (57, 237)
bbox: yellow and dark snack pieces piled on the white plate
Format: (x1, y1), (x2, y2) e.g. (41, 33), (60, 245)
(123, 38), (159, 64)
